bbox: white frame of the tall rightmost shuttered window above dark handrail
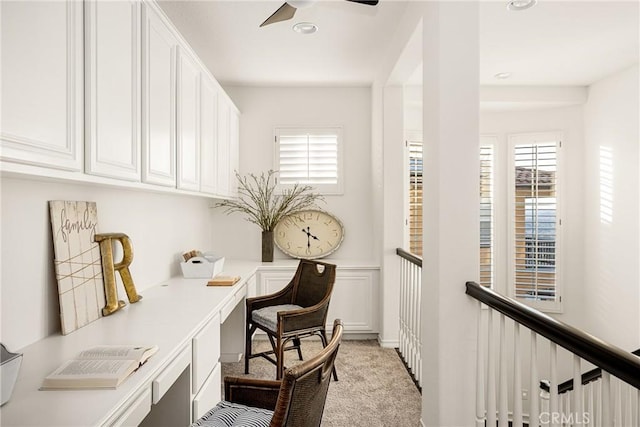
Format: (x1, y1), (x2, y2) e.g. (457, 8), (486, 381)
(506, 131), (564, 313)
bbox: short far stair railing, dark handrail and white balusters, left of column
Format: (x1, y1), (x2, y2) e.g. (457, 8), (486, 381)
(396, 248), (422, 387)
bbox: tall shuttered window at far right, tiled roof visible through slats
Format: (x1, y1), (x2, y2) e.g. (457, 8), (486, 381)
(509, 133), (561, 310)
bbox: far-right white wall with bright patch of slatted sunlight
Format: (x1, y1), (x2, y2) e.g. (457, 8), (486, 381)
(582, 65), (640, 350)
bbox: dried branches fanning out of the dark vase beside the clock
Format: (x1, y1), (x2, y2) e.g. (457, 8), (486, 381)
(215, 170), (324, 231)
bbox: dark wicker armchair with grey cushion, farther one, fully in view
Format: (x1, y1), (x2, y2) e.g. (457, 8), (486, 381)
(244, 259), (338, 381)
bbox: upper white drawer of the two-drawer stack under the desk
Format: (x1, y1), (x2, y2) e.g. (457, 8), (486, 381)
(191, 315), (220, 394)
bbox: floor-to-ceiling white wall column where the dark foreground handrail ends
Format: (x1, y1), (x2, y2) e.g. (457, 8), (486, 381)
(422, 1), (479, 427)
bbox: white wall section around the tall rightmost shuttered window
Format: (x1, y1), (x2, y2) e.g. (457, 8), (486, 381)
(480, 106), (584, 327)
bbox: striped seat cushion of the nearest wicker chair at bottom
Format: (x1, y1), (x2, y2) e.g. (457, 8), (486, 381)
(191, 400), (273, 427)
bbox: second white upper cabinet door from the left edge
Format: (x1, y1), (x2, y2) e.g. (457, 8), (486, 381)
(85, 0), (140, 181)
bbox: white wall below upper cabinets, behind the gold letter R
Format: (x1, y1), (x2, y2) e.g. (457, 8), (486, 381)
(0, 177), (210, 350)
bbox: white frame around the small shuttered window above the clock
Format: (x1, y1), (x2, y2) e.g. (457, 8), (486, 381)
(273, 126), (345, 195)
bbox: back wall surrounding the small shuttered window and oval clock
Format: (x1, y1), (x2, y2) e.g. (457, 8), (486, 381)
(211, 87), (381, 262)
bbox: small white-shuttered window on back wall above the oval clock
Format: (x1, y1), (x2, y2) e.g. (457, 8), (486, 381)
(275, 128), (342, 194)
